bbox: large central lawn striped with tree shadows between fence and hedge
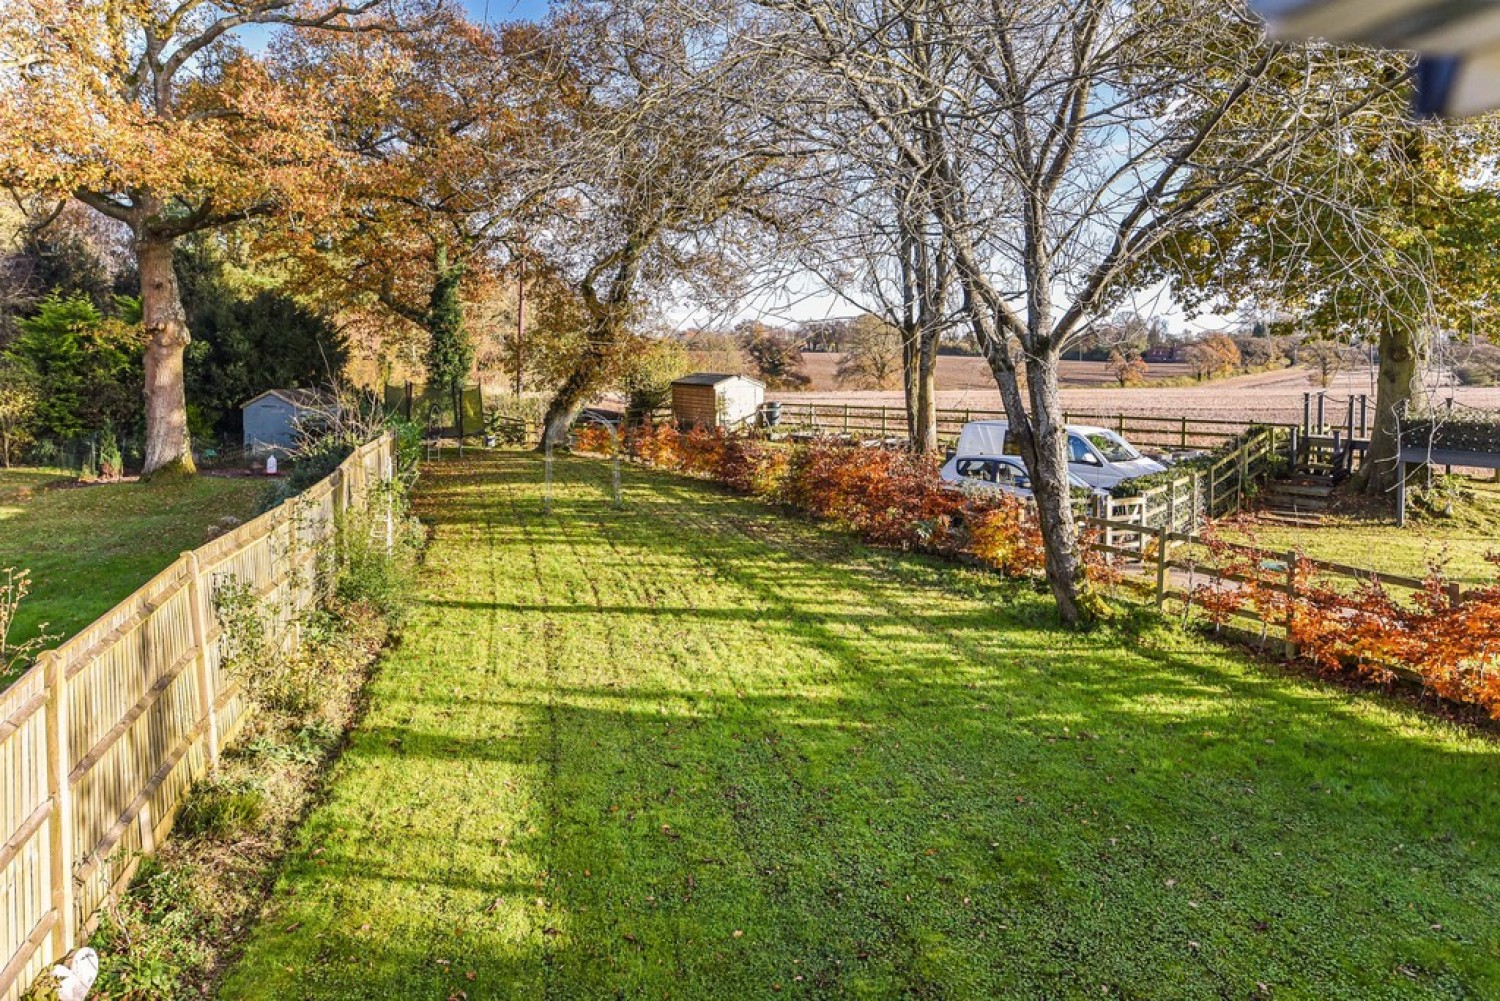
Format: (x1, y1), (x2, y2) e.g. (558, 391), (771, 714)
(222, 452), (1500, 1001)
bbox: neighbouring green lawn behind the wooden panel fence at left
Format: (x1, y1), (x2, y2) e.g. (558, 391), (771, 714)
(0, 470), (266, 666)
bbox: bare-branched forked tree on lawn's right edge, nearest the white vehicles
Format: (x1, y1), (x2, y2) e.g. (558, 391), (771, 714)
(738, 0), (1397, 621)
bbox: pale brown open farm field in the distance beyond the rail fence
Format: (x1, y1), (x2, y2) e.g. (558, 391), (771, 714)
(767, 354), (1500, 423)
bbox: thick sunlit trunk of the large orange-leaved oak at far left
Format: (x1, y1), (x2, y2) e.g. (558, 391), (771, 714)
(135, 233), (197, 477)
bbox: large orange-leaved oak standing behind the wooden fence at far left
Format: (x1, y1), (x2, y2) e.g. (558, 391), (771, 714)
(0, 0), (420, 476)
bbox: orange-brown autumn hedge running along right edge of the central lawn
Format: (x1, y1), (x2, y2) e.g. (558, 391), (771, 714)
(575, 425), (1500, 717)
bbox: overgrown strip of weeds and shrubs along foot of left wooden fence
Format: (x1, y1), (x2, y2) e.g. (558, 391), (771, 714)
(23, 498), (422, 1001)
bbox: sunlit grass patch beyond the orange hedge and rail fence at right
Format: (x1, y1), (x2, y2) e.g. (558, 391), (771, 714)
(1227, 477), (1500, 584)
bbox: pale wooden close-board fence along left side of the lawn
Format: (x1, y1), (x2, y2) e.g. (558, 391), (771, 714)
(0, 435), (395, 1001)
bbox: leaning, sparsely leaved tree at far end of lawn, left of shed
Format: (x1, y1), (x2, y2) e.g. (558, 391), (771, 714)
(528, 0), (795, 446)
